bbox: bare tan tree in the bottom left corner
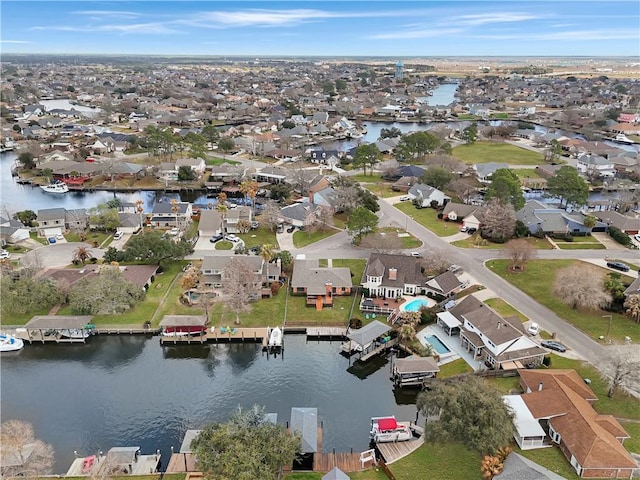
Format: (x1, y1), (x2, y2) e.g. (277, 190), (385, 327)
(0, 420), (54, 478)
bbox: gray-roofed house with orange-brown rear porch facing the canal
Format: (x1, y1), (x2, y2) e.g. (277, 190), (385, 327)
(291, 259), (352, 310)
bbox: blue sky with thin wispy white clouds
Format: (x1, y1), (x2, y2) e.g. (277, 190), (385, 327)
(0, 0), (640, 57)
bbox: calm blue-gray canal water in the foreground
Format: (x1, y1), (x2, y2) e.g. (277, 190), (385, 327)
(0, 335), (416, 473)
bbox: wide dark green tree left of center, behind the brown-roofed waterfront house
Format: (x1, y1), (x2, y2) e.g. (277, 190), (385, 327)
(125, 232), (193, 265)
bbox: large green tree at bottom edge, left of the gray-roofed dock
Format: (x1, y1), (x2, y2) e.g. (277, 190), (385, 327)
(191, 406), (300, 480)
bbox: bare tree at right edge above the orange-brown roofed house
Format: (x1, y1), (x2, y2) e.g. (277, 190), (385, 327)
(601, 345), (640, 398)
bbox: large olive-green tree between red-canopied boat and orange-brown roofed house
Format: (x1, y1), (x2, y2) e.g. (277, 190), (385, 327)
(416, 376), (514, 454)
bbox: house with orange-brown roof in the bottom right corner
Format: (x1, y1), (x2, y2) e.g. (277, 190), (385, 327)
(516, 370), (637, 478)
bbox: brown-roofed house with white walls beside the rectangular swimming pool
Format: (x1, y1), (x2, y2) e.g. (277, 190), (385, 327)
(438, 295), (545, 370)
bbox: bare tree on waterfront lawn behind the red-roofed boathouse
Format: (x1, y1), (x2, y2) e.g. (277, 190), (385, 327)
(222, 257), (260, 324)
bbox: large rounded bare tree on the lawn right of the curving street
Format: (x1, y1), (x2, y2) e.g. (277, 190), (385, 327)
(553, 264), (611, 310)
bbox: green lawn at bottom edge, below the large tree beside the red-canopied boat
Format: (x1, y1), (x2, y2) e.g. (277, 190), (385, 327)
(389, 442), (481, 480)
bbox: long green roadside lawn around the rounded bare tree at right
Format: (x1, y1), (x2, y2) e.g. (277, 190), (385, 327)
(486, 259), (640, 343)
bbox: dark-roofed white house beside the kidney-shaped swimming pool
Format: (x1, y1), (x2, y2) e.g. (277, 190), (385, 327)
(362, 253), (425, 299)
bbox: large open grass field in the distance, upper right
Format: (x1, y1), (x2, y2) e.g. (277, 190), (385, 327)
(453, 142), (544, 165)
